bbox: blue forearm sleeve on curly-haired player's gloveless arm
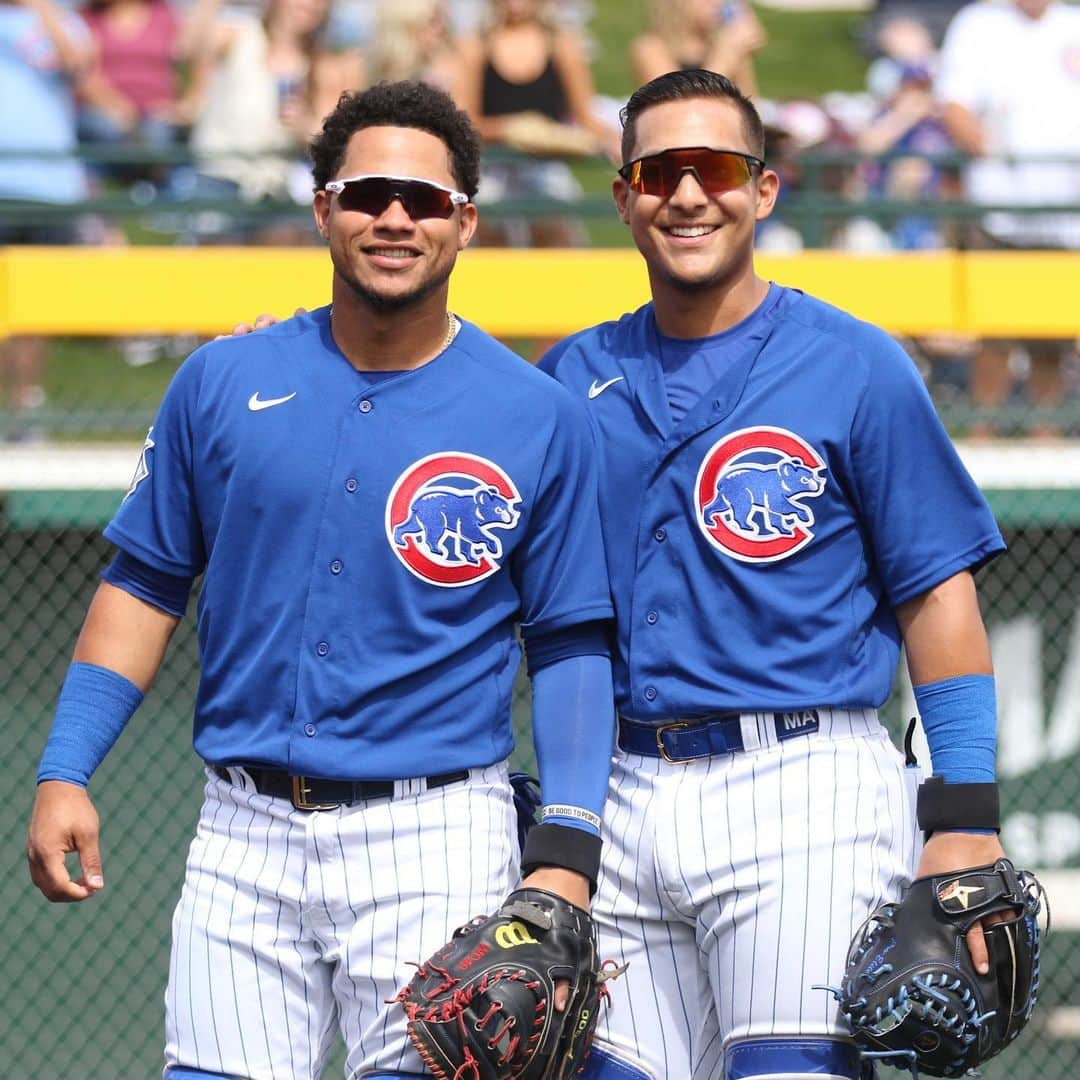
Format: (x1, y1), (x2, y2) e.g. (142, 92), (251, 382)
(38, 662), (143, 787)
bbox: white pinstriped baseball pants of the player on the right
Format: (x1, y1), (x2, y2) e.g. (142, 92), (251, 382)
(593, 708), (921, 1080)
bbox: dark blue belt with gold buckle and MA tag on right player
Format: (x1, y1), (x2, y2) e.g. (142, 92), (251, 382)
(619, 708), (820, 765)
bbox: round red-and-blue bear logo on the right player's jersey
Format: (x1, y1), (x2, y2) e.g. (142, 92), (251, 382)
(694, 427), (825, 563)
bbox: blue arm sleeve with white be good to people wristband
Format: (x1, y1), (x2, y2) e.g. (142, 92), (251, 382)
(532, 657), (615, 836)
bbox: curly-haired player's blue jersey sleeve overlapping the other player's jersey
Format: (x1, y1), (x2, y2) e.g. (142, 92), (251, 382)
(511, 390), (612, 632)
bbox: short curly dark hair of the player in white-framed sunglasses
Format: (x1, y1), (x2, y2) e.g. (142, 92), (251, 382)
(308, 81), (480, 199)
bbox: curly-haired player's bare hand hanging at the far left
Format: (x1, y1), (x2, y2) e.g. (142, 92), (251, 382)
(26, 780), (105, 903)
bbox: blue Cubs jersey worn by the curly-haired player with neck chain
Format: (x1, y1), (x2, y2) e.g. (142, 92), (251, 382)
(106, 309), (611, 779)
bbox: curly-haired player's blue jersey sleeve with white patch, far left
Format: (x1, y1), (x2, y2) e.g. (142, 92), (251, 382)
(105, 350), (206, 578)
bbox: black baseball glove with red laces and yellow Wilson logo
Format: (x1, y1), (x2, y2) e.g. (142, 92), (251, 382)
(397, 889), (618, 1080)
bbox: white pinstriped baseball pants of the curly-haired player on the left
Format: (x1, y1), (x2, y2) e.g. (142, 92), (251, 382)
(165, 764), (519, 1080)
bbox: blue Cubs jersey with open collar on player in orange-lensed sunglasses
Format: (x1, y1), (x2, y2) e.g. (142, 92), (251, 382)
(541, 289), (1004, 720)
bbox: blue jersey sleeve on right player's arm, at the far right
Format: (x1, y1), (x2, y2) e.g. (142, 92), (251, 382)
(851, 332), (1005, 607)
